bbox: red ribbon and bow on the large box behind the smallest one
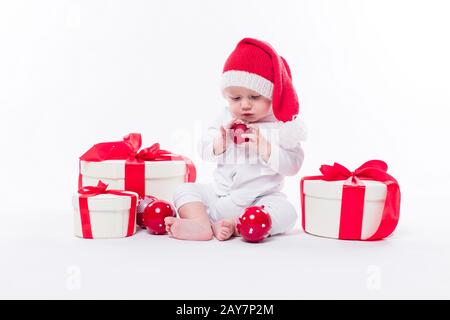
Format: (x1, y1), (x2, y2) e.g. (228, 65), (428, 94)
(78, 133), (196, 197)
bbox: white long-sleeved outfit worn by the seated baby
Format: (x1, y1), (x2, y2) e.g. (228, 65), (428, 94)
(174, 107), (304, 235)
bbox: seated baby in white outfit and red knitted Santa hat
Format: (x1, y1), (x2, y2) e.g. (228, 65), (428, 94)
(165, 38), (303, 240)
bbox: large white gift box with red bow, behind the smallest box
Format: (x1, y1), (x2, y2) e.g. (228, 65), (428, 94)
(78, 133), (196, 201)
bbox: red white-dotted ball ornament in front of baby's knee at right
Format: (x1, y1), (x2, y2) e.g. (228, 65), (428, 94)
(236, 206), (272, 242)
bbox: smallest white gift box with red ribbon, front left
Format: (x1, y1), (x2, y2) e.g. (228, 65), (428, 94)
(73, 181), (138, 239)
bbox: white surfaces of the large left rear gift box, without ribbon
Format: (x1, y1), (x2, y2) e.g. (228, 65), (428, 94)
(80, 160), (186, 202)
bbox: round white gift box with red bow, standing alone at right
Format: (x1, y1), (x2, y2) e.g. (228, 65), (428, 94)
(300, 160), (400, 240)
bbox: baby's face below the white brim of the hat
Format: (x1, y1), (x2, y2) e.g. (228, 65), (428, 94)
(224, 87), (271, 123)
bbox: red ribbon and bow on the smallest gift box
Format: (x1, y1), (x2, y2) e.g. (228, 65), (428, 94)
(78, 181), (137, 239)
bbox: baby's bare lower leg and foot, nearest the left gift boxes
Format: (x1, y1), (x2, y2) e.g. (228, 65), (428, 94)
(164, 201), (213, 240)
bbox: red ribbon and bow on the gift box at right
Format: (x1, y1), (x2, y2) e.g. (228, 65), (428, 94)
(300, 160), (400, 241)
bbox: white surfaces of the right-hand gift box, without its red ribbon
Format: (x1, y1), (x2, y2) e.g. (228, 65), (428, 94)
(303, 180), (387, 240)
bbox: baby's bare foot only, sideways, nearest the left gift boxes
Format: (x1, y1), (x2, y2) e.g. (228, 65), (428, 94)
(164, 217), (213, 240)
